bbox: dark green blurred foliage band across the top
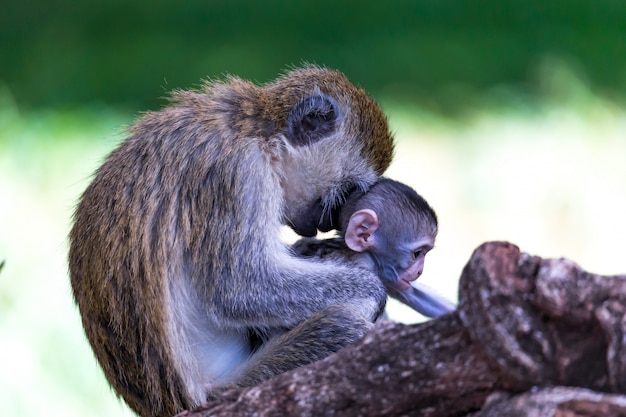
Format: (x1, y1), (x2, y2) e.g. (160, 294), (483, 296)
(0, 0), (626, 111)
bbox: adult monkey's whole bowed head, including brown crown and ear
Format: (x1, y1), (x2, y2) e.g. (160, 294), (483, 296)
(268, 66), (393, 236)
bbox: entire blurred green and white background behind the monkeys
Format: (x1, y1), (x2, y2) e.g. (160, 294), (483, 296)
(0, 0), (626, 416)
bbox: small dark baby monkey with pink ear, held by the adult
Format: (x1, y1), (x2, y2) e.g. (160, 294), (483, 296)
(294, 178), (455, 317)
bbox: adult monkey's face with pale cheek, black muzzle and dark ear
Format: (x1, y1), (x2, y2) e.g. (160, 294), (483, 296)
(279, 92), (386, 236)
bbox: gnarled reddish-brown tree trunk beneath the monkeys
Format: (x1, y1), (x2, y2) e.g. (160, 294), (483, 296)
(176, 242), (626, 417)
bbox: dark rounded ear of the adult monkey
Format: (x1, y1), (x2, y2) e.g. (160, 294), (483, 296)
(287, 92), (338, 146)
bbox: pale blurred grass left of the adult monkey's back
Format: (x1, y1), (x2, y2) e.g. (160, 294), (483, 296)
(0, 95), (130, 416)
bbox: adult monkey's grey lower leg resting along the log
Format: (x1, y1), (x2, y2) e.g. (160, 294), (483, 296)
(236, 305), (373, 386)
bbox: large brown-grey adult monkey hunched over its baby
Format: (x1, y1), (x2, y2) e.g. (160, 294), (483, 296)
(69, 66), (393, 416)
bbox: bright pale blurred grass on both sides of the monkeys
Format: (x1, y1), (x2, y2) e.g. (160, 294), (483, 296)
(0, 63), (626, 416)
